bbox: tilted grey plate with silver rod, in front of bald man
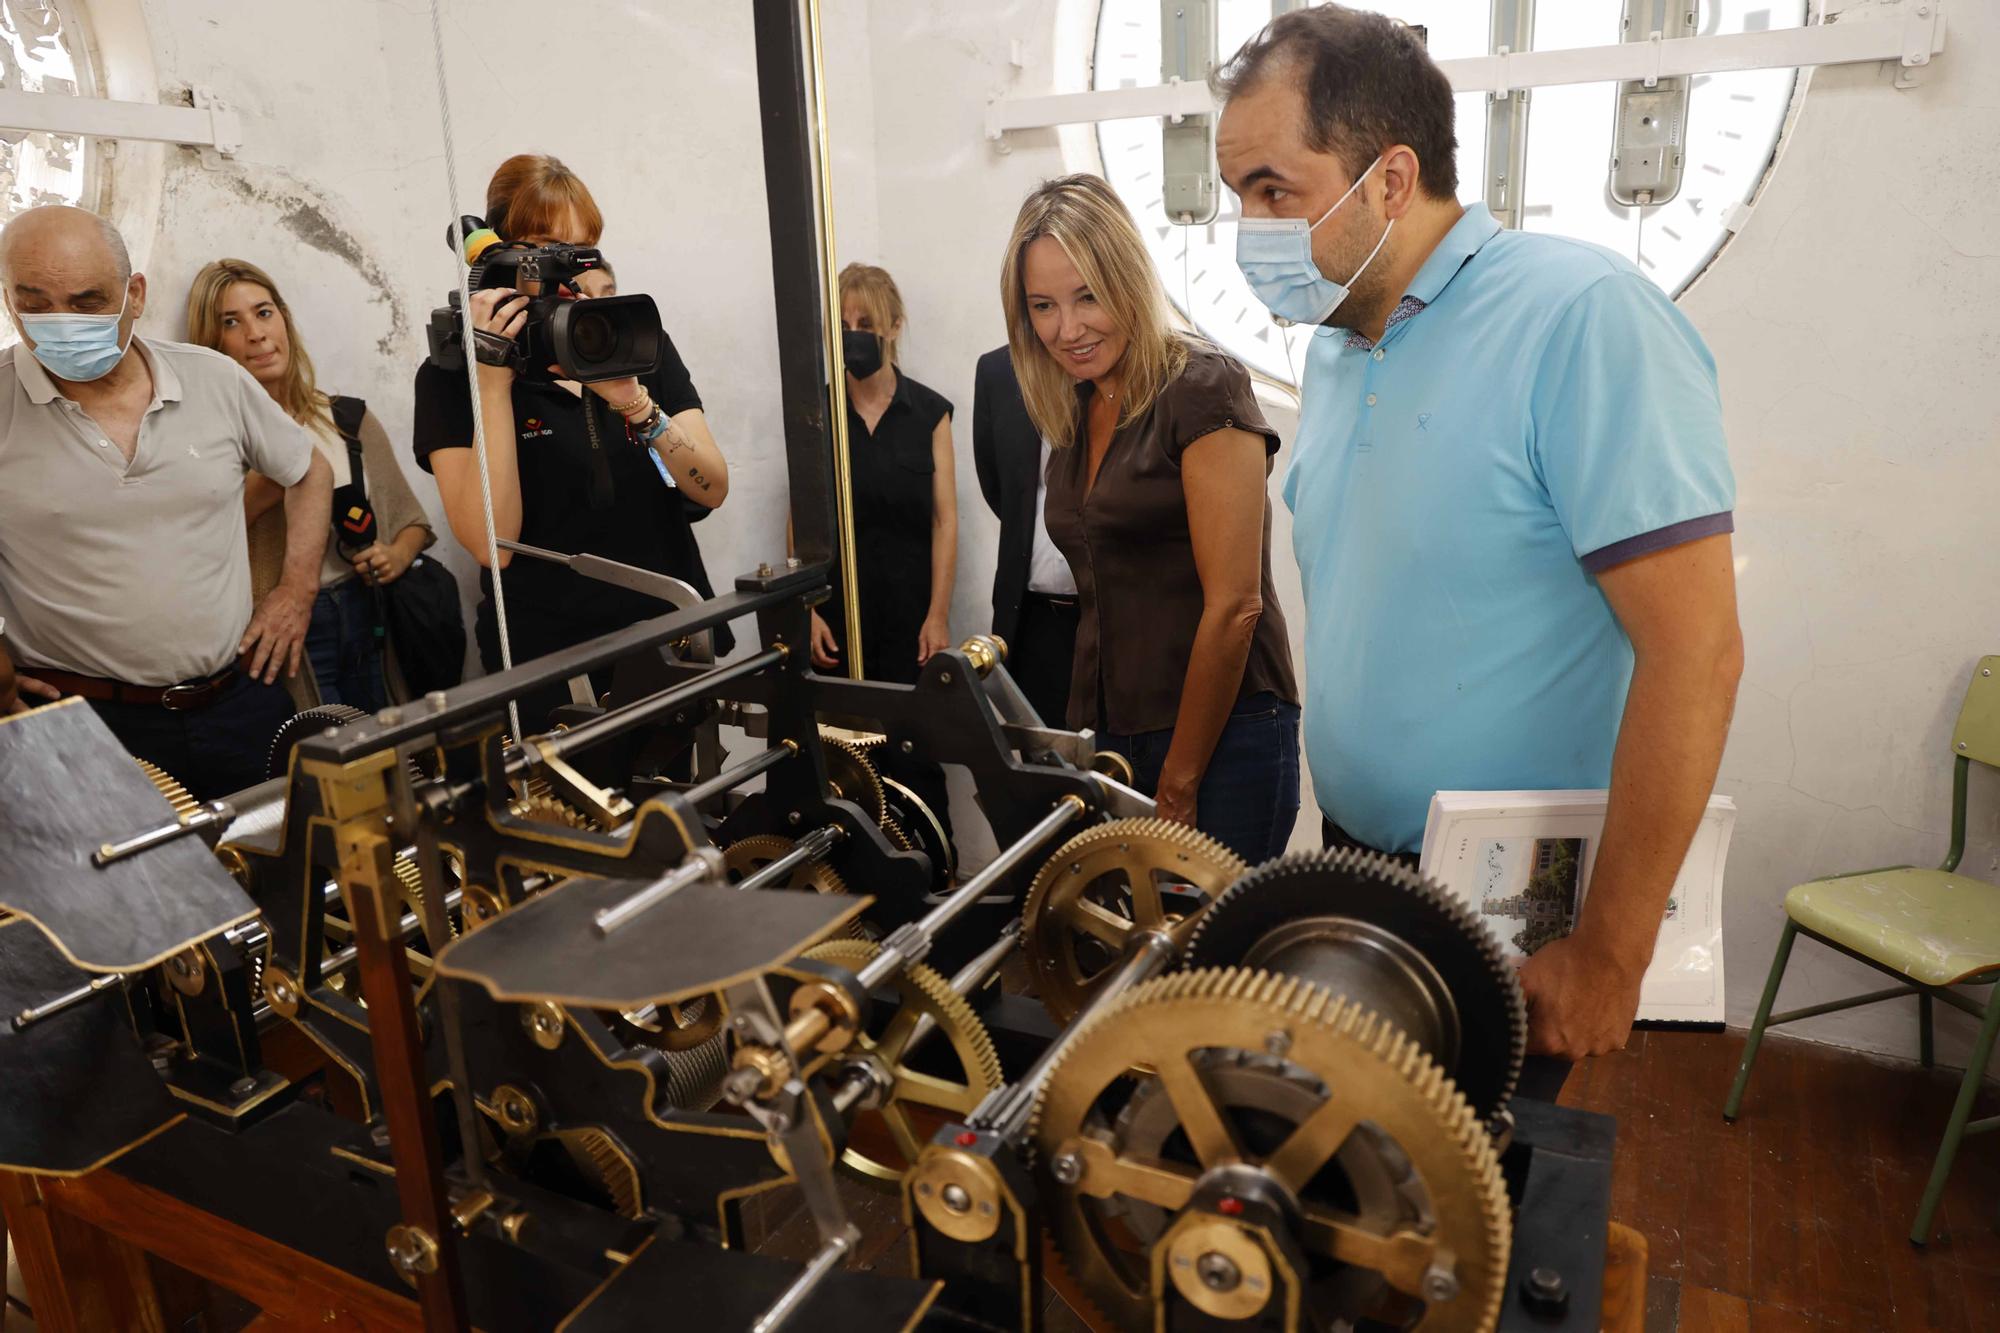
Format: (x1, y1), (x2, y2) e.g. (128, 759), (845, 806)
(0, 699), (256, 973)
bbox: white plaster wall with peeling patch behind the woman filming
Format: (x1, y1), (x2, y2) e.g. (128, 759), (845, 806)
(92, 0), (878, 664)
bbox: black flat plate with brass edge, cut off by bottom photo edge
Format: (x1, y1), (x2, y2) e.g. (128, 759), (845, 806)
(556, 1237), (942, 1333)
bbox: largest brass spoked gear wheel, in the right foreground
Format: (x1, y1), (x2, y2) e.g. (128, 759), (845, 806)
(1030, 967), (1512, 1333)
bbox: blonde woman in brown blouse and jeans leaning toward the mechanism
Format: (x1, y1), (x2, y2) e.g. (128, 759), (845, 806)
(1000, 174), (1298, 865)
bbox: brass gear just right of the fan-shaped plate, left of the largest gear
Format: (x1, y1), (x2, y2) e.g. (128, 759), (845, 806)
(806, 939), (1006, 1187)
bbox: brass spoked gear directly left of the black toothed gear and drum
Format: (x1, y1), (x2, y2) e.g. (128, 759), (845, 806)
(1022, 819), (1250, 1023)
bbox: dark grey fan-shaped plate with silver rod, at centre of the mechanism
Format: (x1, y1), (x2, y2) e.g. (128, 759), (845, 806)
(438, 877), (874, 1009)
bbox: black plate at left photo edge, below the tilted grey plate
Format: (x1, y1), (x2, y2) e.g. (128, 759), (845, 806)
(0, 919), (180, 1175)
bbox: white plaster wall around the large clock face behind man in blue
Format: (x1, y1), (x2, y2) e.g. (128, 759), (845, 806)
(870, 0), (2000, 1061)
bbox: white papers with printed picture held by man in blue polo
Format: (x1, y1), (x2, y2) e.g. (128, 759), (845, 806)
(1418, 791), (1736, 1025)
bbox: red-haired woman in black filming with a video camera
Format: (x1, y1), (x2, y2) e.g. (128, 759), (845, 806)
(414, 154), (730, 731)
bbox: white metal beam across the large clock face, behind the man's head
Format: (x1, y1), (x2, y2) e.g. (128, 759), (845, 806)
(986, 0), (1944, 138)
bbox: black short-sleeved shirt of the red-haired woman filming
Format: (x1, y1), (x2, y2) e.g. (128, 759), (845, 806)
(412, 336), (728, 671)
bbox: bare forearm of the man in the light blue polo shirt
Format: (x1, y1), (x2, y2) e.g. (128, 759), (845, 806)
(1576, 644), (1742, 973)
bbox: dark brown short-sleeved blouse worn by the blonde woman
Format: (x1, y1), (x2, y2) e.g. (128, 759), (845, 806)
(1044, 342), (1298, 735)
